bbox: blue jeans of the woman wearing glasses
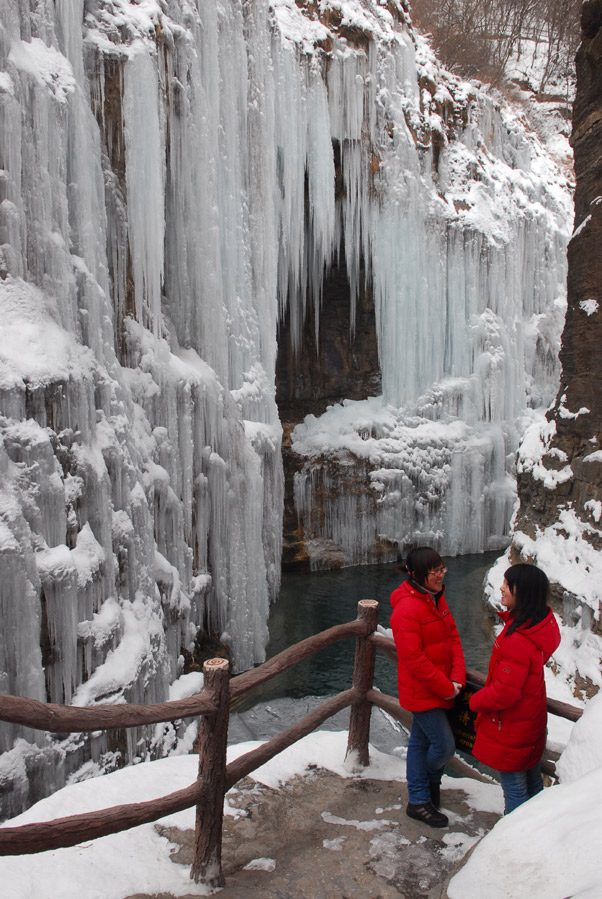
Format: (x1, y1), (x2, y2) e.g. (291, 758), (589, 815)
(406, 709), (456, 805)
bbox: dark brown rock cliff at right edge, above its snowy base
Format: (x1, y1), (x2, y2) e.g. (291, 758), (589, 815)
(516, 0), (602, 550)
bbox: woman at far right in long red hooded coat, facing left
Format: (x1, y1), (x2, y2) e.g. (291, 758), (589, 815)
(470, 564), (560, 814)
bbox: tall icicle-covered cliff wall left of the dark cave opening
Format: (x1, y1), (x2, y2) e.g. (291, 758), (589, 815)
(0, 0), (283, 813)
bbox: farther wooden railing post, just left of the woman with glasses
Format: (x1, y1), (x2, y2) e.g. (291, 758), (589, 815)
(347, 599), (378, 768)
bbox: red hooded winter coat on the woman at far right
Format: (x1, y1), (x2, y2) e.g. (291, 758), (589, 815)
(470, 610), (560, 771)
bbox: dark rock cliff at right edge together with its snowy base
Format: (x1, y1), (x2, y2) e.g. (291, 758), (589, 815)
(511, 0), (602, 684)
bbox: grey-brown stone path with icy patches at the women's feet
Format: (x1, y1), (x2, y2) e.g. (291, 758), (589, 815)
(129, 769), (501, 899)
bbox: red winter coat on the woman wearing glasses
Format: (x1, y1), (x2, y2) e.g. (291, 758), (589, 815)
(391, 581), (466, 712)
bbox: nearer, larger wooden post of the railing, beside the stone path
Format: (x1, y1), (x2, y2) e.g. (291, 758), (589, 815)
(190, 659), (230, 888)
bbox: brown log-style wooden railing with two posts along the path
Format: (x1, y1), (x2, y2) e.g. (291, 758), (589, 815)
(0, 599), (581, 888)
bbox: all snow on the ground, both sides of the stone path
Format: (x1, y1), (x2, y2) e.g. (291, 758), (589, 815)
(0, 696), (602, 899)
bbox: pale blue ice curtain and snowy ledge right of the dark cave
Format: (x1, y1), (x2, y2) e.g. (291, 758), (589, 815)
(284, 4), (572, 568)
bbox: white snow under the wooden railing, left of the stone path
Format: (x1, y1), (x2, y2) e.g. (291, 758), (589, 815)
(0, 732), (408, 899)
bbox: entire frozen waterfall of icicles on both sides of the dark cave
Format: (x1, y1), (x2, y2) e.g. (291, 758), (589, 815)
(0, 0), (570, 813)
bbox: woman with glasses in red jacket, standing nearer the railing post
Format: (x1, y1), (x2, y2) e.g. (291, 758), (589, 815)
(391, 546), (466, 827)
